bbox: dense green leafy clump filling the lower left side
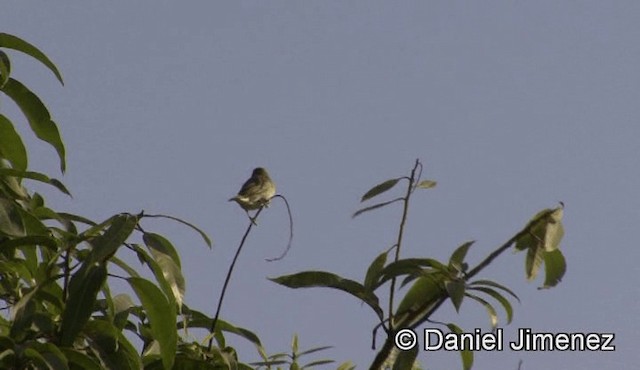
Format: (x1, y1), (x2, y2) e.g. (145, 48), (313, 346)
(0, 33), (264, 369)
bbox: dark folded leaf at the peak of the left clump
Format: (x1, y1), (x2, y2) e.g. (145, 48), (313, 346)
(89, 213), (138, 262)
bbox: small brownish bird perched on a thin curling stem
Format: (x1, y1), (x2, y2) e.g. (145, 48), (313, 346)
(229, 167), (276, 224)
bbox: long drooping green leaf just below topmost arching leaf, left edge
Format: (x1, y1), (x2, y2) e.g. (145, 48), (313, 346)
(0, 78), (66, 173)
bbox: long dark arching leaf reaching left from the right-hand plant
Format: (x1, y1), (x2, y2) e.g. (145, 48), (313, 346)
(269, 271), (383, 319)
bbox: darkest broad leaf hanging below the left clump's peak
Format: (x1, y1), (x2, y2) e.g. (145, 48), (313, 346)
(60, 261), (107, 346)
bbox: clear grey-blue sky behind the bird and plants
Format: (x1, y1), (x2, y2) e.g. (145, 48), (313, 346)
(0, 0), (640, 369)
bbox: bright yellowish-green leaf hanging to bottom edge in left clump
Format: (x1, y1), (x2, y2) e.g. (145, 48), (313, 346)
(127, 277), (178, 369)
